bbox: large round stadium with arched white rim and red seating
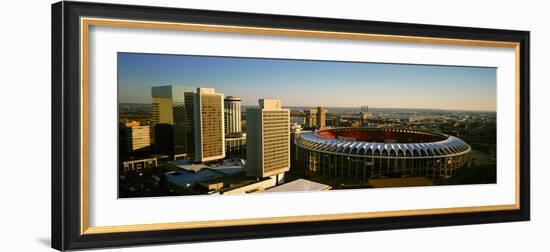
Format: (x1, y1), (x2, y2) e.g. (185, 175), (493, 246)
(293, 128), (471, 182)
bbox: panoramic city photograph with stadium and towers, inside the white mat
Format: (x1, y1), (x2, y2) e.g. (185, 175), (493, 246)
(117, 52), (497, 198)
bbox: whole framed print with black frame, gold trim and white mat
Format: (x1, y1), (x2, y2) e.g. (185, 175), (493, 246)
(52, 2), (530, 250)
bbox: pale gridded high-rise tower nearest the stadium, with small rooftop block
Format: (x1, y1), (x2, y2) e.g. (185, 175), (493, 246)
(246, 99), (290, 182)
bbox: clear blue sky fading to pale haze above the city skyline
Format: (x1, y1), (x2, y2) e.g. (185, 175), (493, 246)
(118, 53), (496, 111)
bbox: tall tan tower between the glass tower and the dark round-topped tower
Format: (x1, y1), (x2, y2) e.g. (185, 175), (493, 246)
(194, 88), (225, 163)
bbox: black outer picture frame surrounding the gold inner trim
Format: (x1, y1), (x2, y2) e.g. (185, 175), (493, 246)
(51, 2), (530, 250)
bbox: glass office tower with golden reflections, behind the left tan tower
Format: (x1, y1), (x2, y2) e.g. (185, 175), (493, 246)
(151, 86), (195, 155)
